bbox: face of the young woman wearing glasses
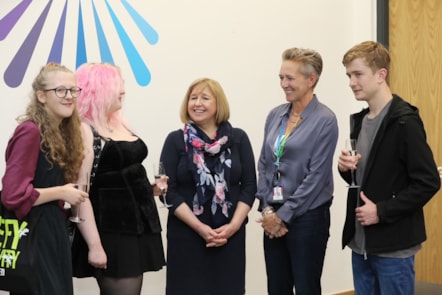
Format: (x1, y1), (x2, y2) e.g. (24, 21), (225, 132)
(37, 71), (77, 122)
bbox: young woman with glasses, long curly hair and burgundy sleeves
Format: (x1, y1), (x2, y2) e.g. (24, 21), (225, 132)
(2, 63), (88, 295)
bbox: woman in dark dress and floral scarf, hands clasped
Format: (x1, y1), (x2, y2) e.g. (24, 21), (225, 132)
(161, 78), (256, 295)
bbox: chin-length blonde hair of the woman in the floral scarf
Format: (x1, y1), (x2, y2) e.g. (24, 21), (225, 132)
(180, 78), (230, 125)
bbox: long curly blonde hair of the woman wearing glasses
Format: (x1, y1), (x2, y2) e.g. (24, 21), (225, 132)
(17, 63), (84, 182)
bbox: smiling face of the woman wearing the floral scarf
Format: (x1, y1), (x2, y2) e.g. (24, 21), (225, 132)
(187, 84), (217, 126)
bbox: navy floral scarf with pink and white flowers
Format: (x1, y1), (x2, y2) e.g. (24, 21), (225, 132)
(183, 121), (232, 218)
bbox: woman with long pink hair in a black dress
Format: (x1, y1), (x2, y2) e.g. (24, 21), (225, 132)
(72, 63), (167, 295)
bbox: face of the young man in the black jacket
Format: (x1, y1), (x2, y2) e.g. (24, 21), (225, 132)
(346, 58), (386, 101)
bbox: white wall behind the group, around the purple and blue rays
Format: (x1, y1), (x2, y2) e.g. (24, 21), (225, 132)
(0, 0), (376, 295)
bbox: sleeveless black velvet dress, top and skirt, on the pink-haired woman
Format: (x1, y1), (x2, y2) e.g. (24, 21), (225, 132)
(72, 139), (165, 278)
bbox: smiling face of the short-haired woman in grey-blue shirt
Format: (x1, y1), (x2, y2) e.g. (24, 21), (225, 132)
(279, 60), (317, 102)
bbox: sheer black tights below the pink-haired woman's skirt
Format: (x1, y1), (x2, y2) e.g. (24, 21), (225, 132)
(97, 275), (143, 295)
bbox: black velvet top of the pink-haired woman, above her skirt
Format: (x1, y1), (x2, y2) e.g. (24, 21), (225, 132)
(89, 139), (161, 234)
